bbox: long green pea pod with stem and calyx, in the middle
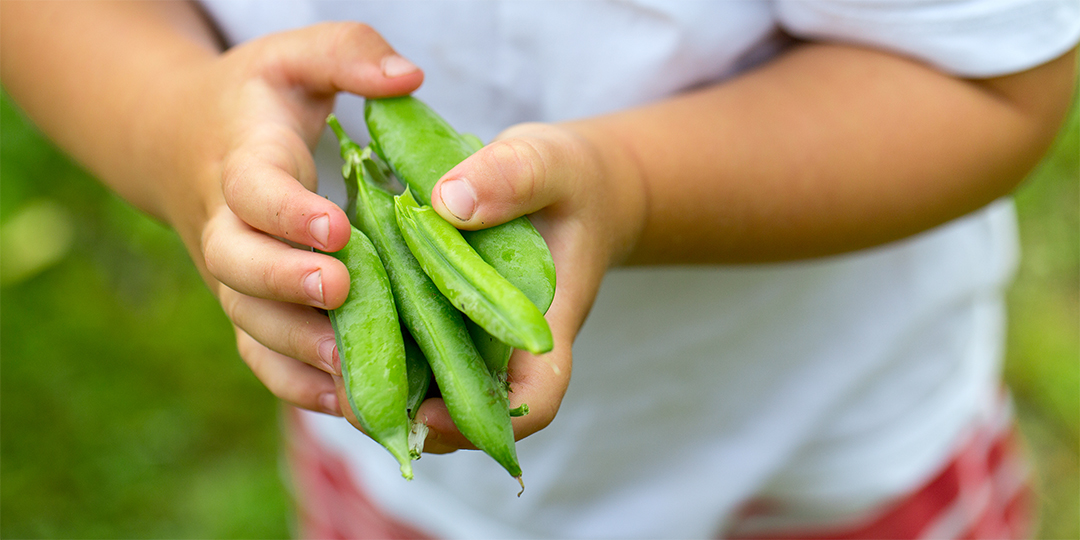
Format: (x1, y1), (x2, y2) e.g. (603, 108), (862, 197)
(327, 117), (522, 482)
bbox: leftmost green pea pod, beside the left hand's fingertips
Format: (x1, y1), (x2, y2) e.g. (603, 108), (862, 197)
(321, 228), (413, 478)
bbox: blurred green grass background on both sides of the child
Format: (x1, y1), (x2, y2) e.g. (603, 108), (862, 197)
(0, 82), (1080, 539)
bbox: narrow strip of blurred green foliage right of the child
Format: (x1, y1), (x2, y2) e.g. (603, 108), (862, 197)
(1005, 97), (1080, 539)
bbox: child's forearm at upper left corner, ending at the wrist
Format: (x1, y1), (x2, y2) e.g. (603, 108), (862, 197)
(0, 0), (218, 218)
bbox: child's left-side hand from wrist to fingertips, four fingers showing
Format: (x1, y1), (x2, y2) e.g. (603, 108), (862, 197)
(162, 24), (423, 415)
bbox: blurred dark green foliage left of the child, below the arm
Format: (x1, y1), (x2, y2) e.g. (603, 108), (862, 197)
(0, 90), (291, 538)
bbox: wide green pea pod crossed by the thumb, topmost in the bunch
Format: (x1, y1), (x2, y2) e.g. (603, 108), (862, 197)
(364, 96), (555, 313)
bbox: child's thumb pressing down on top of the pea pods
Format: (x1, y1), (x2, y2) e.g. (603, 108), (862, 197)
(431, 124), (572, 230)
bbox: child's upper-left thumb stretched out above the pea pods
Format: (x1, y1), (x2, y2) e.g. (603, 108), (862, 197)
(259, 22), (423, 97)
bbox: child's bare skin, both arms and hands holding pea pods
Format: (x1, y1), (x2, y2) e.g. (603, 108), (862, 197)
(0, 0), (1076, 453)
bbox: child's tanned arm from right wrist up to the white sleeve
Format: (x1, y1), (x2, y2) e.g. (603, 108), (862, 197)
(573, 45), (1075, 264)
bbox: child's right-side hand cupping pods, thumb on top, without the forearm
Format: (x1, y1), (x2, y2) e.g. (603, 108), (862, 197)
(418, 123), (644, 453)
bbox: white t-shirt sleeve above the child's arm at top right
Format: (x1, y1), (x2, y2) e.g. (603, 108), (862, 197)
(775, 0), (1080, 78)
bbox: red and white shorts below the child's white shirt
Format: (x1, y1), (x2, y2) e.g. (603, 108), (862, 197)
(287, 399), (1034, 540)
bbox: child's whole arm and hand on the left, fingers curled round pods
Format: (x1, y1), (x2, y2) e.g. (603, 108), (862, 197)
(0, 0), (423, 427)
